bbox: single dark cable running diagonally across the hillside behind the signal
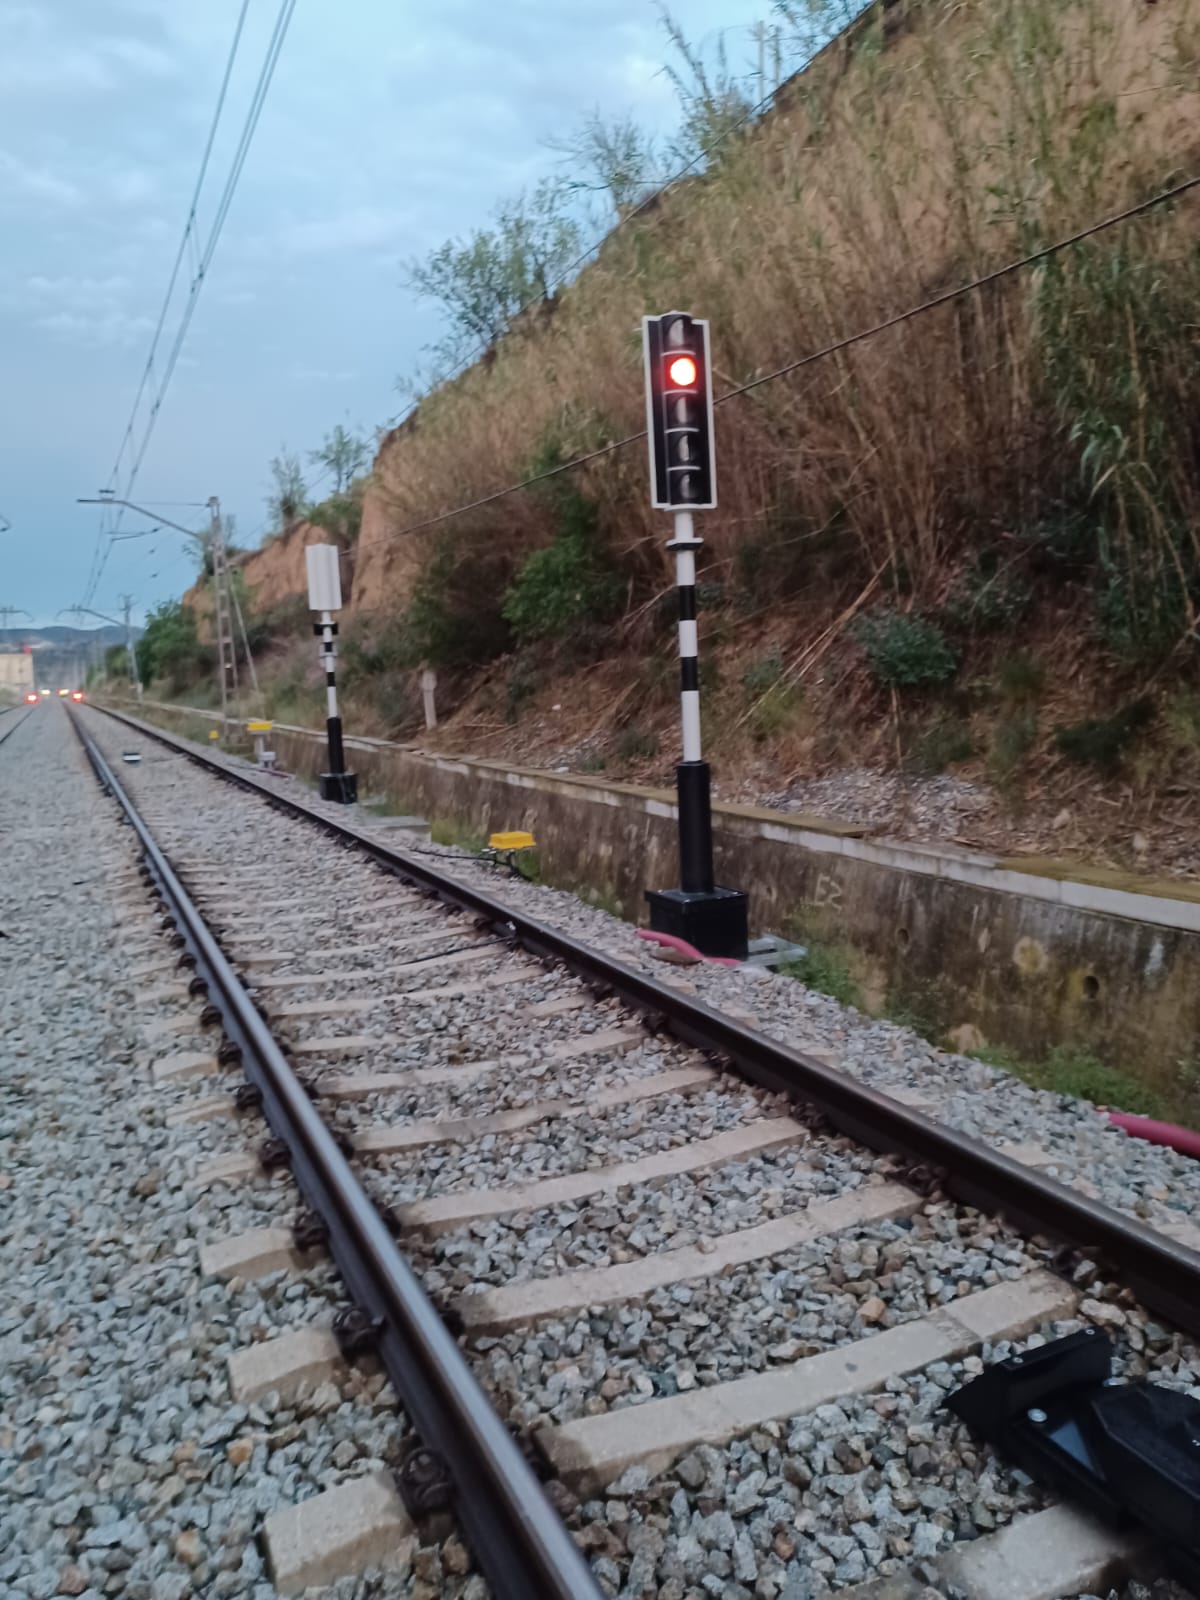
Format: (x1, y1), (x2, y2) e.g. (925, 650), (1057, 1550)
(357, 176), (1200, 550)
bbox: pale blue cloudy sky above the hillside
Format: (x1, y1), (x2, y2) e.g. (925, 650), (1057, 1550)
(0, 0), (770, 622)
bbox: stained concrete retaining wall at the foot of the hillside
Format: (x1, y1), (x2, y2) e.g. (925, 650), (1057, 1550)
(129, 704), (1200, 1086)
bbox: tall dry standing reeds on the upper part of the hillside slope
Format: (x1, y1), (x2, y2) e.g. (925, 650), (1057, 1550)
(355, 0), (1200, 681)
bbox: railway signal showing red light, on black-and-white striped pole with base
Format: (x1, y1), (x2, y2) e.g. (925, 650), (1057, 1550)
(642, 310), (749, 958)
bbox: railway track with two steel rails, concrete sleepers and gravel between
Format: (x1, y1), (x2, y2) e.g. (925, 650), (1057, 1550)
(61, 712), (1200, 1600)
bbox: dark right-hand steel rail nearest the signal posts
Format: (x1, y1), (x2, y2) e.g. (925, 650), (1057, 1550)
(93, 707), (1200, 1333)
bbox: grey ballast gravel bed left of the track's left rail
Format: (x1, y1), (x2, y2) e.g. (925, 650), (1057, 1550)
(0, 706), (486, 1600)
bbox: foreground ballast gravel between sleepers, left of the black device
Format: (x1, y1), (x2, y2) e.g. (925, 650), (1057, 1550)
(550, 1320), (1189, 1600)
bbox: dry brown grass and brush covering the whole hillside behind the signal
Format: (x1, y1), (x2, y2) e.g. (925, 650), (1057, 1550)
(219, 0), (1200, 889)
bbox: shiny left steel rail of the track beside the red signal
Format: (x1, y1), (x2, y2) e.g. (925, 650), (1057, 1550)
(72, 717), (600, 1600)
